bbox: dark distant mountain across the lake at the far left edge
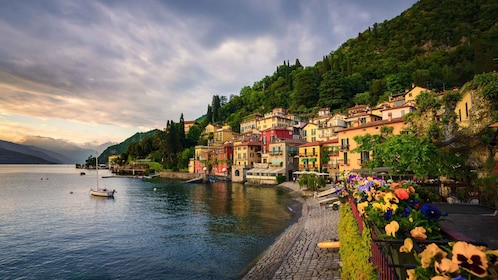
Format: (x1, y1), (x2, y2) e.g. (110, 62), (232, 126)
(0, 140), (64, 164)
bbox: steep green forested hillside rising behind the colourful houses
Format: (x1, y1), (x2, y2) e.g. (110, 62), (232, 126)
(210, 0), (498, 131)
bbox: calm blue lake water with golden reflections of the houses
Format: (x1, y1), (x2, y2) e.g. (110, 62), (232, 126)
(0, 165), (301, 279)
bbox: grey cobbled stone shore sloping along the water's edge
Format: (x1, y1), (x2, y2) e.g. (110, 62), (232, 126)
(243, 182), (340, 280)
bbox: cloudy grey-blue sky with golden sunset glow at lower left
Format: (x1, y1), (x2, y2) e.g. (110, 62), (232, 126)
(0, 0), (417, 148)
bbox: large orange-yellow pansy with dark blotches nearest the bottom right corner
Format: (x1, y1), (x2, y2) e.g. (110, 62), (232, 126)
(452, 241), (488, 277)
